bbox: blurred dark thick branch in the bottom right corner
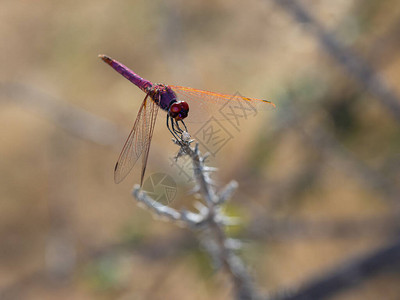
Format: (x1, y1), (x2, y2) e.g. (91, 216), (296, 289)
(273, 241), (400, 300)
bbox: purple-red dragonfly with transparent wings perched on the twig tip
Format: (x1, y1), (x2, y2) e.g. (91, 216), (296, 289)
(99, 54), (275, 185)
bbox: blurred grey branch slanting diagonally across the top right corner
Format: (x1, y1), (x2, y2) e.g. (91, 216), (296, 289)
(275, 0), (400, 123)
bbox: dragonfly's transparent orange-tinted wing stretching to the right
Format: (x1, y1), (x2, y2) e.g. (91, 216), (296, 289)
(169, 85), (275, 122)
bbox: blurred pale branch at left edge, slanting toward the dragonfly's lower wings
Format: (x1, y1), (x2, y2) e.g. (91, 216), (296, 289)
(0, 83), (123, 150)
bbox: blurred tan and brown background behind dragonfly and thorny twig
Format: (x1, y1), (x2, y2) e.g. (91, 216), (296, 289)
(0, 0), (400, 299)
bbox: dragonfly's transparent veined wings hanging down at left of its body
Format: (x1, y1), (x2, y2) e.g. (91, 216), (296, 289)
(114, 95), (158, 183)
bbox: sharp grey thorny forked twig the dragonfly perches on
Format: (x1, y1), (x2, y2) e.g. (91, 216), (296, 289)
(132, 140), (258, 299)
